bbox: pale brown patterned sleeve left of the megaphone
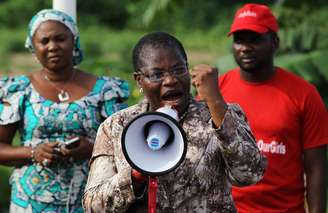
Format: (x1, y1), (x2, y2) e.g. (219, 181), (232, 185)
(83, 117), (136, 212)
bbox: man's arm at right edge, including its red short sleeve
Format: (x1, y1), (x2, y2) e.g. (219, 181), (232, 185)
(301, 86), (328, 213)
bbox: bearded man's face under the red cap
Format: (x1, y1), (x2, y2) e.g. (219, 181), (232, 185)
(232, 30), (277, 72)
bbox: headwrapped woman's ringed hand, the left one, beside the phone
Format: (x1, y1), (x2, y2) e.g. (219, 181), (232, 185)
(33, 142), (59, 166)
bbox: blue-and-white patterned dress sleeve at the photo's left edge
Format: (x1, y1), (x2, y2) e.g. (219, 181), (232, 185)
(0, 77), (26, 125)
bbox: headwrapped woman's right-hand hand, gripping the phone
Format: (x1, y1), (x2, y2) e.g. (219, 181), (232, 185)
(60, 137), (93, 160)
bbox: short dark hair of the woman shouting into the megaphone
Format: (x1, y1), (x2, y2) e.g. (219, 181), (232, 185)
(132, 32), (187, 72)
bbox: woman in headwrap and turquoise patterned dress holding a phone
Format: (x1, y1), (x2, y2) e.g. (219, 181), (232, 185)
(0, 10), (128, 213)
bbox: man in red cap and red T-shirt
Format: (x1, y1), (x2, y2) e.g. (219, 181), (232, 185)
(193, 4), (328, 213)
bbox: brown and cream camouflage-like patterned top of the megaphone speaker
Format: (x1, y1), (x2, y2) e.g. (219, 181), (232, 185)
(83, 100), (267, 213)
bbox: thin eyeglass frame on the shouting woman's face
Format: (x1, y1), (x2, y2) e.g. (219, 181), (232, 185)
(134, 63), (189, 83)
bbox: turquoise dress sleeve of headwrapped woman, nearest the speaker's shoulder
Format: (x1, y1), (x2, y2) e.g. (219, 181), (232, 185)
(101, 77), (129, 118)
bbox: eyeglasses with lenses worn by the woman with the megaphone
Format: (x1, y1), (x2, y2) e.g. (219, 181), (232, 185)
(136, 65), (188, 83)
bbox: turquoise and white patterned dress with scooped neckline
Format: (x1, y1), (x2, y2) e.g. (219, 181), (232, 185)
(0, 76), (129, 213)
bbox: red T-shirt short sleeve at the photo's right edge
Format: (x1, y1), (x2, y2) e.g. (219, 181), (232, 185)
(301, 86), (328, 149)
